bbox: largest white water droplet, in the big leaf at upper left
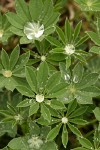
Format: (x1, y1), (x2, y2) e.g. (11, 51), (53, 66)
(24, 22), (44, 40)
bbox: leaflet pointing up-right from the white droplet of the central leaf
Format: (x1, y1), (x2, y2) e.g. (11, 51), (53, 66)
(46, 72), (61, 91)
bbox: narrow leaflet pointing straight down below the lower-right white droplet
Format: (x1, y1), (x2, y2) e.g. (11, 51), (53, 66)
(62, 125), (68, 148)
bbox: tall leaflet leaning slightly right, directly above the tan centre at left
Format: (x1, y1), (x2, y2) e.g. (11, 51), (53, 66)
(10, 46), (20, 70)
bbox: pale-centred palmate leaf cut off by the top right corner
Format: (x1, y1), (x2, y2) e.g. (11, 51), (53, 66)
(75, 0), (100, 11)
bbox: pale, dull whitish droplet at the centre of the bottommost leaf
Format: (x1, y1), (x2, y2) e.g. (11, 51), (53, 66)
(28, 136), (43, 150)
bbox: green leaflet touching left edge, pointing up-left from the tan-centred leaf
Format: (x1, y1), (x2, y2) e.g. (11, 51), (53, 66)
(1, 49), (9, 70)
